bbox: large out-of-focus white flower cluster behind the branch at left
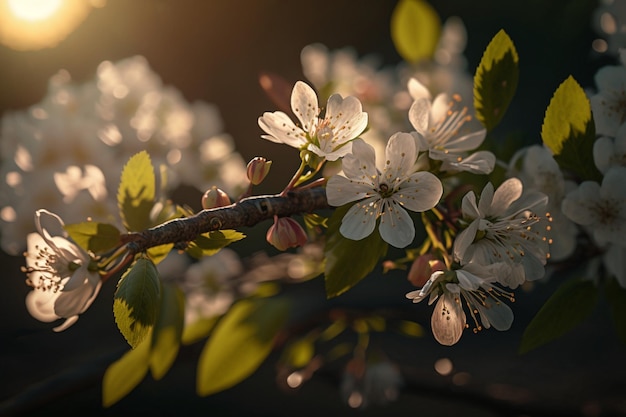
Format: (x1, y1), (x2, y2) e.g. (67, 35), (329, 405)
(0, 56), (246, 253)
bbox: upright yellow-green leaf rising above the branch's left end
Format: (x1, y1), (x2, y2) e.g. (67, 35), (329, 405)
(117, 151), (155, 232)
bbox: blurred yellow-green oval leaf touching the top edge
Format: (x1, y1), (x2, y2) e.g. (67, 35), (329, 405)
(391, 0), (441, 63)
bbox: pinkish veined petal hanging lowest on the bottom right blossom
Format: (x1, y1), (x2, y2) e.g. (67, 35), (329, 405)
(430, 292), (465, 346)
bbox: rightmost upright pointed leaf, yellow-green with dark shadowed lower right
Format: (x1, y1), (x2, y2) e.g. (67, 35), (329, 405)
(541, 75), (602, 181)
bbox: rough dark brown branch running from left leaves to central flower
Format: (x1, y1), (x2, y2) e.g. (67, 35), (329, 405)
(123, 187), (329, 253)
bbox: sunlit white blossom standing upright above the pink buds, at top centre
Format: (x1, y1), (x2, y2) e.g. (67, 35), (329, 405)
(259, 81), (368, 161)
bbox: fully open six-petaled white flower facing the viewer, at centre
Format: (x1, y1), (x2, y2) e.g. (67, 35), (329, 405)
(326, 133), (443, 248)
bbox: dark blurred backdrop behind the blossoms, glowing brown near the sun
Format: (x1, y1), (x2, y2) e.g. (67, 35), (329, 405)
(0, 0), (626, 417)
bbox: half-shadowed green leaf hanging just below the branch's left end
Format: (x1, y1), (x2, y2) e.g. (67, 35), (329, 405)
(113, 256), (160, 348)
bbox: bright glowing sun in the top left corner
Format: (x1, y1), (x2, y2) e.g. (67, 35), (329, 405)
(0, 0), (106, 50)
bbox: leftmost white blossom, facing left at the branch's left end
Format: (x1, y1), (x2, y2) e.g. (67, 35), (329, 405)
(24, 210), (102, 332)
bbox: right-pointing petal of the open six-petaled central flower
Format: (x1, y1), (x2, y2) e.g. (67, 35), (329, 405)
(392, 171), (443, 212)
